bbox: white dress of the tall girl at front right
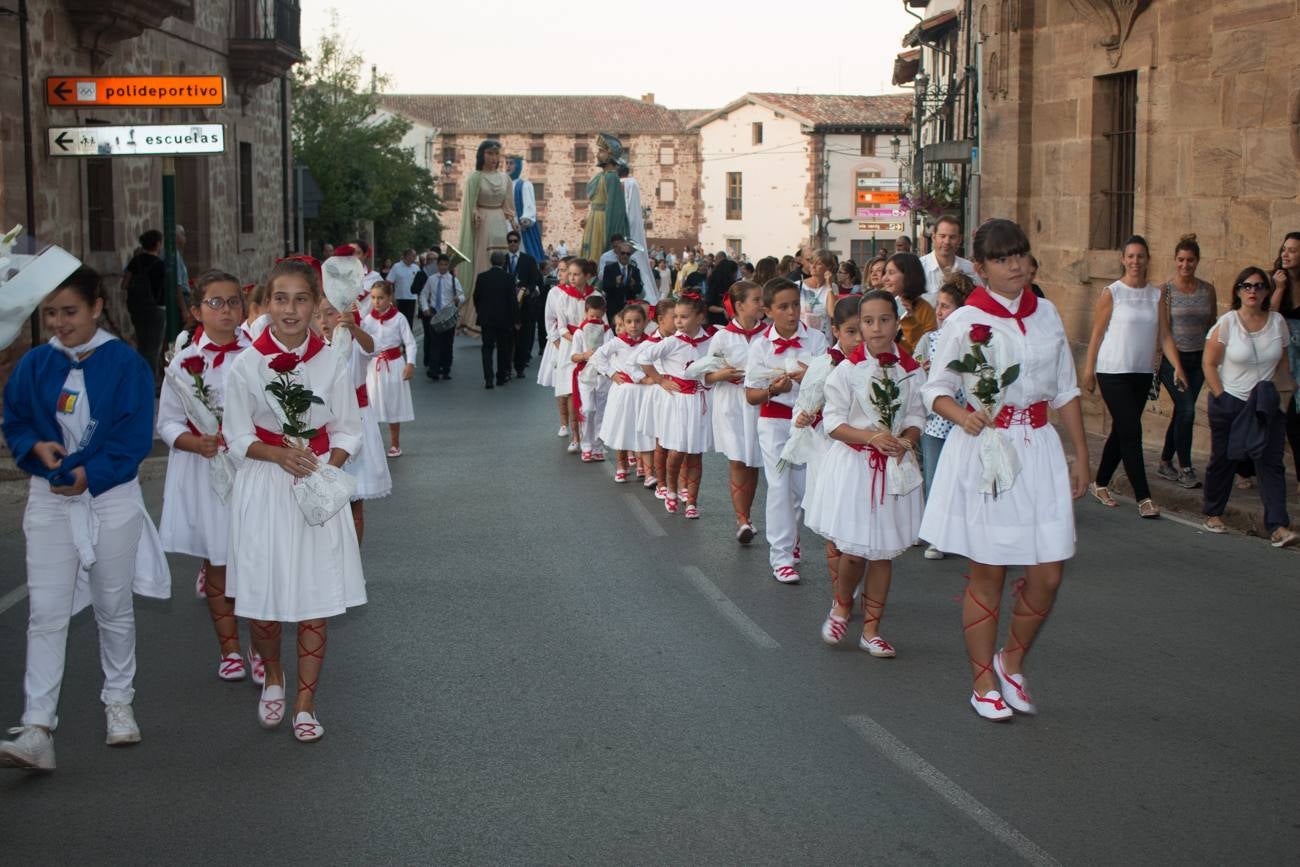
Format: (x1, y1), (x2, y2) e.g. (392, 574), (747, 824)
(920, 290), (1079, 565)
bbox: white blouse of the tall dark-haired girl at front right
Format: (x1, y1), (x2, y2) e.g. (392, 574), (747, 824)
(922, 290), (1079, 411)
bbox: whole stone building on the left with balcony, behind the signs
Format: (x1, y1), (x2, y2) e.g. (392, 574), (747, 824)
(0, 0), (300, 378)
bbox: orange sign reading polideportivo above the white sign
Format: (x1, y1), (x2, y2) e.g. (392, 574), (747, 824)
(46, 75), (226, 108)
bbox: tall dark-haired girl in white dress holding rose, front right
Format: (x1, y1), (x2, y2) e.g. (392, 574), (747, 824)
(920, 220), (1088, 720)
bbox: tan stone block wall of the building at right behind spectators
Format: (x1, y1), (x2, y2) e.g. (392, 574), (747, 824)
(979, 0), (1300, 442)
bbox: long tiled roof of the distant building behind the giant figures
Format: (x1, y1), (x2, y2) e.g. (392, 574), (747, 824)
(380, 94), (689, 135)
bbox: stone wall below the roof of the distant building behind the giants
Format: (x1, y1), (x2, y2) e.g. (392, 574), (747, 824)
(436, 133), (699, 255)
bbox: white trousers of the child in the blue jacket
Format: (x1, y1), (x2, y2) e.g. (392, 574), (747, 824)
(22, 489), (144, 729)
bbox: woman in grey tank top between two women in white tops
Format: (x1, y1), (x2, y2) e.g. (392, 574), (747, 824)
(1156, 235), (1218, 487)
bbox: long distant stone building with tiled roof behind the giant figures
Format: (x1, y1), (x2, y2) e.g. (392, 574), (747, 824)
(380, 94), (699, 252)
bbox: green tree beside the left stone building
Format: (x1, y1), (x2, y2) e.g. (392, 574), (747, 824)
(294, 18), (442, 257)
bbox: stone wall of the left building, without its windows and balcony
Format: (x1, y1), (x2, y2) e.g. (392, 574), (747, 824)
(0, 0), (290, 380)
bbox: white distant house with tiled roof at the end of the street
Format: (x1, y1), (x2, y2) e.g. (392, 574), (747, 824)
(689, 94), (913, 264)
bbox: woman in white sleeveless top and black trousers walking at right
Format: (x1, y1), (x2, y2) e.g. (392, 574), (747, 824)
(1083, 235), (1187, 517)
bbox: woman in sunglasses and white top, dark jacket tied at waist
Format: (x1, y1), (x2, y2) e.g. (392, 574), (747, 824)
(1204, 268), (1296, 547)
